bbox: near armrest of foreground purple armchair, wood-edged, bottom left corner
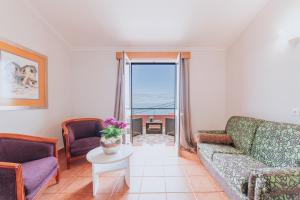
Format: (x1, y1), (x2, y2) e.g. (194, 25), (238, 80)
(0, 162), (25, 200)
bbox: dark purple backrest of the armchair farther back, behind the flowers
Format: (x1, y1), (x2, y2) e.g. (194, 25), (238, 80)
(67, 120), (101, 143)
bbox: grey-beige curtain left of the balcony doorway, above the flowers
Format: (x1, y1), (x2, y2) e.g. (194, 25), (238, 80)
(114, 52), (125, 121)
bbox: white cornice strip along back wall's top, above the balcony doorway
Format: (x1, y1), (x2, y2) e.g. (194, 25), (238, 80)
(71, 46), (228, 52)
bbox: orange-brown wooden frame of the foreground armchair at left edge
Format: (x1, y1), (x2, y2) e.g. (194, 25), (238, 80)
(0, 133), (59, 200)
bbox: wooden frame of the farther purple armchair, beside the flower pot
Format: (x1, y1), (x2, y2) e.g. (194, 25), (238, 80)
(61, 118), (104, 169)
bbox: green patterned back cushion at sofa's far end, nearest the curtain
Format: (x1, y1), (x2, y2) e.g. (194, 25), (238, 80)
(225, 116), (263, 155)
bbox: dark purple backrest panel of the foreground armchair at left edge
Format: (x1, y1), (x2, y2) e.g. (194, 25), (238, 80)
(0, 138), (54, 163)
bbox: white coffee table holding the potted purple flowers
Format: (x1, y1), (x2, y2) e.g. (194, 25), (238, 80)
(86, 144), (133, 196)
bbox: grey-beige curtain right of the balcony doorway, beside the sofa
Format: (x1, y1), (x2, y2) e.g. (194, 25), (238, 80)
(179, 54), (196, 152)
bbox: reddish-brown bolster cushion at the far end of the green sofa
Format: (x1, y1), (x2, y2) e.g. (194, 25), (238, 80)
(199, 133), (233, 144)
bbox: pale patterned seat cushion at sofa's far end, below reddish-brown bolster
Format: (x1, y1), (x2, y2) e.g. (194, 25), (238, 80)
(198, 143), (243, 161)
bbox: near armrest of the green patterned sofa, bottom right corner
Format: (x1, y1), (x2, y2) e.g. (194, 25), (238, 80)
(248, 167), (300, 200)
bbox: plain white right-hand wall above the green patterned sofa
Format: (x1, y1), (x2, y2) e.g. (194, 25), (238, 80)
(227, 0), (300, 123)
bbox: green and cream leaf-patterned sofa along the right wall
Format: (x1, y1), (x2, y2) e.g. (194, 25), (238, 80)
(198, 116), (300, 200)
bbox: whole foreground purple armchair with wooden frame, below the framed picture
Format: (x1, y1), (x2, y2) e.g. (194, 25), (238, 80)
(0, 133), (59, 200)
